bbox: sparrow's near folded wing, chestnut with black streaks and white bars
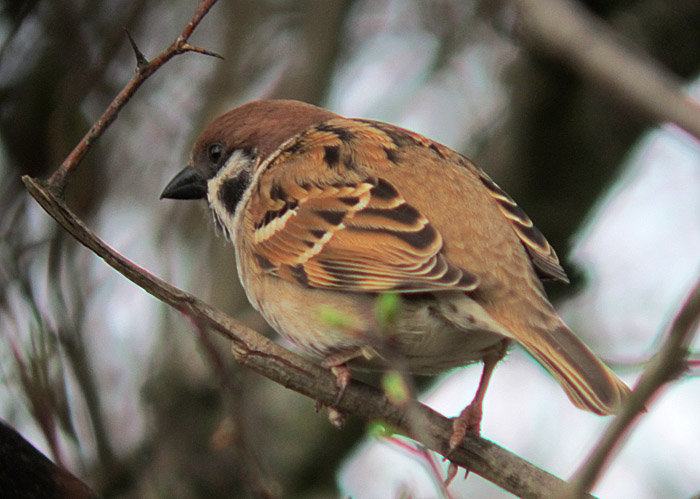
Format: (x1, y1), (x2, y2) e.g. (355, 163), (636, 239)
(243, 120), (478, 292)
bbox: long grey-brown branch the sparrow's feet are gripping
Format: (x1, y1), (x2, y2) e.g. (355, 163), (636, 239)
(22, 176), (584, 498)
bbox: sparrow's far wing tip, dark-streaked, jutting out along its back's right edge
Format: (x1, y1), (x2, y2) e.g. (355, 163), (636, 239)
(476, 168), (569, 283)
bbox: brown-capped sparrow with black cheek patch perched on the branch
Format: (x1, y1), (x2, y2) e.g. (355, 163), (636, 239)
(161, 100), (629, 449)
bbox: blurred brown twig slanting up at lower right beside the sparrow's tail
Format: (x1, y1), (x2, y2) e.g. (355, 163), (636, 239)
(571, 278), (700, 497)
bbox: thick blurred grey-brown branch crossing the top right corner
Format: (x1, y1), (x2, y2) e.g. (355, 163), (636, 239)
(509, 0), (700, 140)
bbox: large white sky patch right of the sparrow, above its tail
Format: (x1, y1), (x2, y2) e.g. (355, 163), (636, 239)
(563, 121), (700, 360)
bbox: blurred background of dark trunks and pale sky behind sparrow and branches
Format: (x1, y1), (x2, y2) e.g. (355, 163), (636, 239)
(0, 0), (700, 498)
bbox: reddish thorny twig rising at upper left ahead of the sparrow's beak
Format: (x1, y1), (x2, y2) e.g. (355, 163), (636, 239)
(47, 0), (221, 198)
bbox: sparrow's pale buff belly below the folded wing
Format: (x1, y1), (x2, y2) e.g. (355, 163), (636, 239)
(241, 266), (508, 374)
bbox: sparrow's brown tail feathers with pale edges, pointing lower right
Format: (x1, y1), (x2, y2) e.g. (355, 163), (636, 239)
(518, 324), (630, 415)
